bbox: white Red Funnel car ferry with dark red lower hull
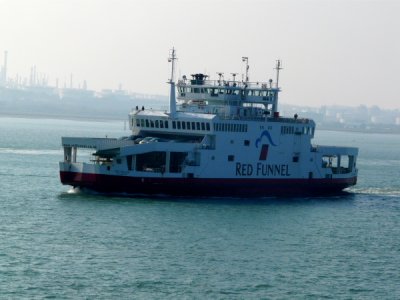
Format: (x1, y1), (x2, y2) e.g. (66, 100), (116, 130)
(59, 49), (358, 197)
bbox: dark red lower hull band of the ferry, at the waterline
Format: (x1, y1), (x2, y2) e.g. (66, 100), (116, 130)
(60, 172), (357, 197)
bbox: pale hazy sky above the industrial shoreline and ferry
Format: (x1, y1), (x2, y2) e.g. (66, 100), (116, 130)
(0, 0), (400, 108)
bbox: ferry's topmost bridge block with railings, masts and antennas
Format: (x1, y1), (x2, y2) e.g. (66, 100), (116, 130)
(170, 58), (281, 118)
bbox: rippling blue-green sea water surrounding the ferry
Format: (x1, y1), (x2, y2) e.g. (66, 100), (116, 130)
(0, 118), (400, 299)
